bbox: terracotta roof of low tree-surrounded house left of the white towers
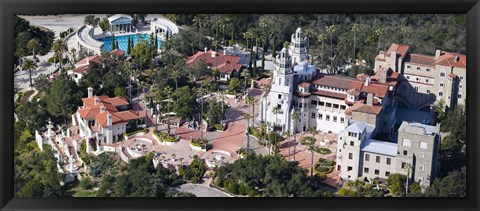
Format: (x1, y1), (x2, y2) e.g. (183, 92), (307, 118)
(186, 50), (242, 73)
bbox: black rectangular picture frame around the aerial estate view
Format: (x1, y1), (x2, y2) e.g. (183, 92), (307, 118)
(0, 0), (480, 210)
